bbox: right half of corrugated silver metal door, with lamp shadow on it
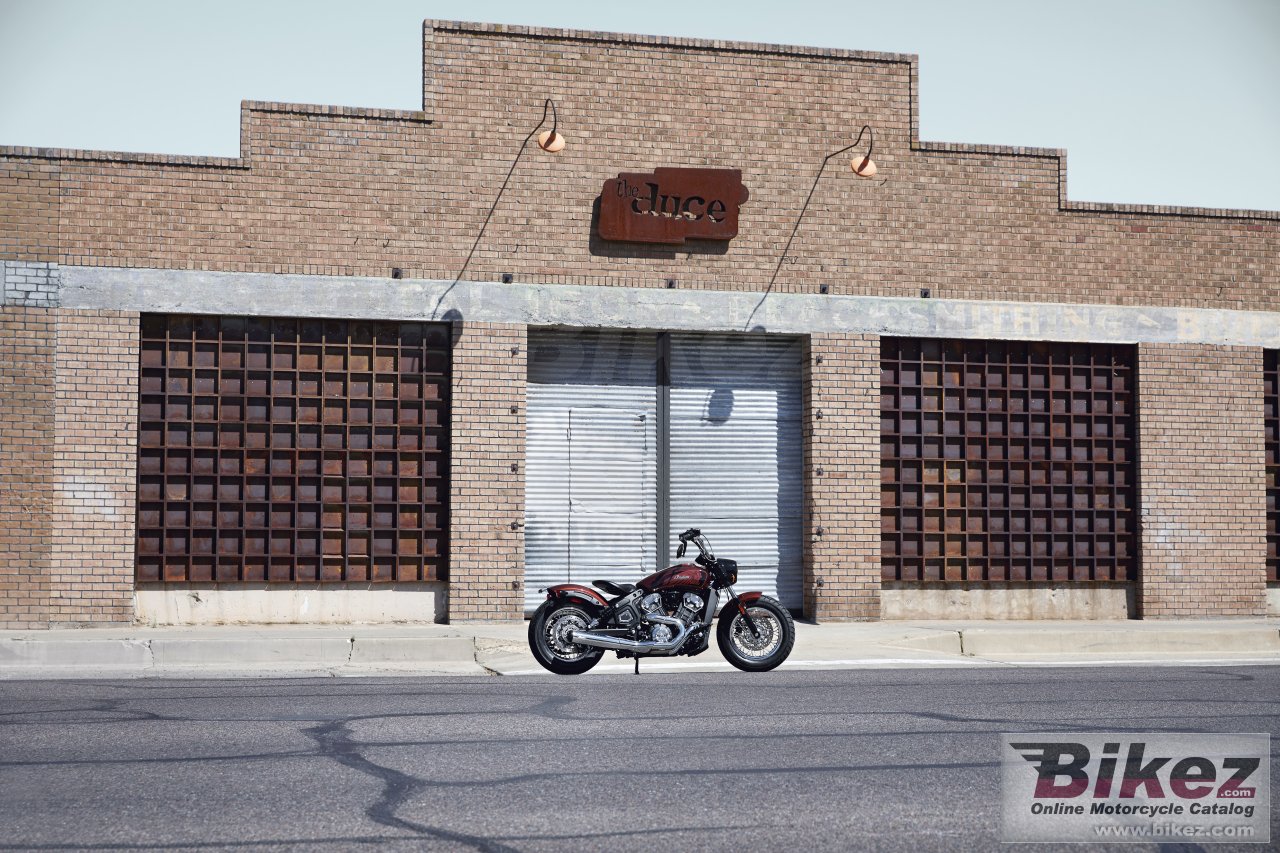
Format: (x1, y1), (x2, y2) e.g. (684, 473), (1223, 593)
(667, 334), (804, 610)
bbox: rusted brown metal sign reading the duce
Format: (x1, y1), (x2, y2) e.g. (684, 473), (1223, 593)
(598, 168), (750, 243)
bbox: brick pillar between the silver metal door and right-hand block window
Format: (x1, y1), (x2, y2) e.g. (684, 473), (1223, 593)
(801, 334), (881, 621)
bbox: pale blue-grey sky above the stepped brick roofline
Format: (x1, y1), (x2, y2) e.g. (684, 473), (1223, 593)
(0, 0), (1280, 210)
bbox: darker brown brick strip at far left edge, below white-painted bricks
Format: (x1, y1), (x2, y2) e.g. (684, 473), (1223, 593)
(0, 306), (55, 628)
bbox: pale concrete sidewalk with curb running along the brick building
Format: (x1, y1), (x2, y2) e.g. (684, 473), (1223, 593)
(0, 619), (1280, 679)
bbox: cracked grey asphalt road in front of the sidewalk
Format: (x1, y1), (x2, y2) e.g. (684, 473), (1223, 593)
(0, 666), (1280, 850)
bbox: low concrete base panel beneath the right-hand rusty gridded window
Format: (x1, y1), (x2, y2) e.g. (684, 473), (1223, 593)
(881, 584), (1137, 620)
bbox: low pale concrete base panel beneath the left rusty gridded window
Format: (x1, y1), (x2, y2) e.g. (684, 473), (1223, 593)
(133, 583), (448, 625)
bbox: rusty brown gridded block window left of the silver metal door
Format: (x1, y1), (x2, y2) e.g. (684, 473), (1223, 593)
(137, 314), (451, 583)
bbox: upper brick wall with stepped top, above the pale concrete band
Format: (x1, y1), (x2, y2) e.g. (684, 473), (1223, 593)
(0, 24), (1280, 309)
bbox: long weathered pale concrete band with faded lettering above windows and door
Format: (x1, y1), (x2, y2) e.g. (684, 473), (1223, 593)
(61, 266), (1280, 348)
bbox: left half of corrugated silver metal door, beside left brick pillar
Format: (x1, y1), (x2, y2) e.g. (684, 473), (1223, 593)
(525, 332), (658, 611)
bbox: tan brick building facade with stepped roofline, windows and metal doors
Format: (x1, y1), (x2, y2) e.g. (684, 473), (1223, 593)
(0, 22), (1280, 628)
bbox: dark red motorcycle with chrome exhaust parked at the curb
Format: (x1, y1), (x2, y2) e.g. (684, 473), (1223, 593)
(529, 529), (796, 675)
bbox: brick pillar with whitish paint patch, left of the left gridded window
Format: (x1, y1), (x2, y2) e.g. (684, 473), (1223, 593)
(49, 309), (138, 625)
